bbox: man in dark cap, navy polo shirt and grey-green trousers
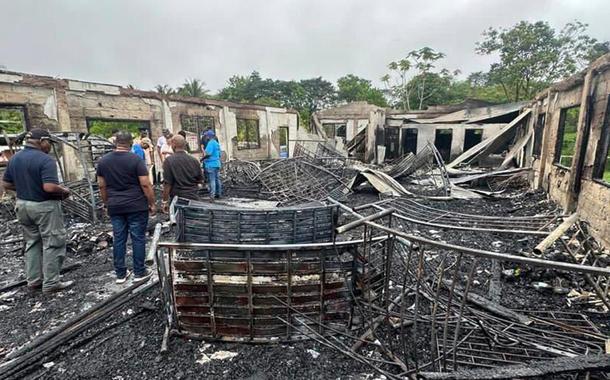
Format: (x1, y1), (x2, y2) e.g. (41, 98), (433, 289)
(3, 129), (74, 293)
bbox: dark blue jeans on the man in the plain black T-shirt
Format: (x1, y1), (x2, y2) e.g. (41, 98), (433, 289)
(110, 211), (148, 278)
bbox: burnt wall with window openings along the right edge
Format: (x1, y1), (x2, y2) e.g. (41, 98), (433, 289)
(529, 54), (610, 246)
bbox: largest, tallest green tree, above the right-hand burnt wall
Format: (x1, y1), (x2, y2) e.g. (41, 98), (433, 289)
(475, 21), (608, 101)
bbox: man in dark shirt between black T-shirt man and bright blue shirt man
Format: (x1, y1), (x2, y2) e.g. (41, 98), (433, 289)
(162, 135), (203, 212)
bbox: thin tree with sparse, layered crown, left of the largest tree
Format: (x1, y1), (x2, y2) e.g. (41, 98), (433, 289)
(381, 47), (453, 110)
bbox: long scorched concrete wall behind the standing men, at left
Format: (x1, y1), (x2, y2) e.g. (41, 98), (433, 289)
(0, 71), (298, 179)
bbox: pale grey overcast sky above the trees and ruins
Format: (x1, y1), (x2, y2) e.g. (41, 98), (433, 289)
(0, 0), (610, 91)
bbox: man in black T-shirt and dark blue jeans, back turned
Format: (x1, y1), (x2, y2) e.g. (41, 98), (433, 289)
(97, 131), (155, 284)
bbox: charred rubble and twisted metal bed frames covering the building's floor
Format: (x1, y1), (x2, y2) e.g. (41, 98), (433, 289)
(0, 140), (610, 379)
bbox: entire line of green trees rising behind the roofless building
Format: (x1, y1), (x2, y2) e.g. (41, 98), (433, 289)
(155, 21), (610, 117)
